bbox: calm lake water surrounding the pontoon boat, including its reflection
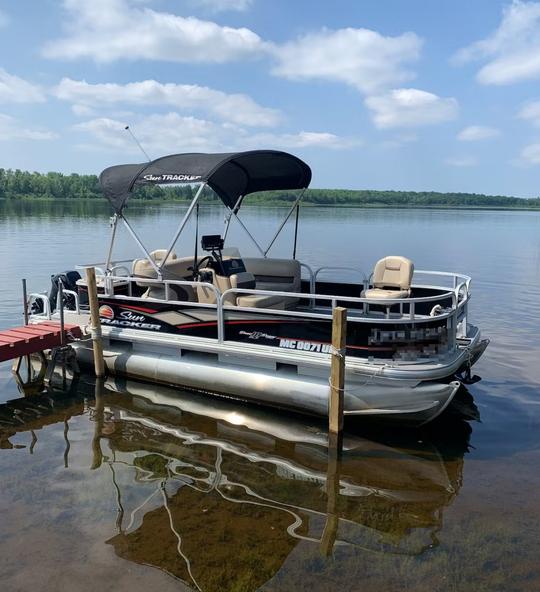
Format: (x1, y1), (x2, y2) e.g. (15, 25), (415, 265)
(0, 202), (540, 592)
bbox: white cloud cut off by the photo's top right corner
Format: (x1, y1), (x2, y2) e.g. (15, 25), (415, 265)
(454, 0), (540, 85)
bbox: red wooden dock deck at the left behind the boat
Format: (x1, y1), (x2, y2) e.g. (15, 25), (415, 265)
(0, 321), (82, 362)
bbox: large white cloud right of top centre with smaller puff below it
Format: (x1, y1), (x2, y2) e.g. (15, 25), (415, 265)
(269, 28), (458, 129)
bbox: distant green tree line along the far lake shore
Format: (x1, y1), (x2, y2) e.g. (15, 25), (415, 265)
(0, 168), (540, 208)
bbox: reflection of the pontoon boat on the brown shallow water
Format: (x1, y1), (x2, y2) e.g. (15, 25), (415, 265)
(0, 382), (470, 590)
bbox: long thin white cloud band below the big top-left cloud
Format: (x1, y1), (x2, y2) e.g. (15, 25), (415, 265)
(53, 78), (281, 127)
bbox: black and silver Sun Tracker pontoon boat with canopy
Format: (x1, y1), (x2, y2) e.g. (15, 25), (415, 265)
(26, 150), (488, 423)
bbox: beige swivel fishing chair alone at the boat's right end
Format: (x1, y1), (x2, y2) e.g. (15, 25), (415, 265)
(362, 256), (414, 299)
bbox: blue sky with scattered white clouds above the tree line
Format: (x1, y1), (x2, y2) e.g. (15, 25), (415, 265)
(0, 0), (540, 197)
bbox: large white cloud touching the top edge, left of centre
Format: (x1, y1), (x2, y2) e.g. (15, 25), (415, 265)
(43, 0), (264, 63)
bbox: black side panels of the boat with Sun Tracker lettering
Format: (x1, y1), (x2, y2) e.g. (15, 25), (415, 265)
(95, 297), (447, 360)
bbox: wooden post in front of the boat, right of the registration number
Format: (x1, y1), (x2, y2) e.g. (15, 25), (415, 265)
(328, 306), (347, 448)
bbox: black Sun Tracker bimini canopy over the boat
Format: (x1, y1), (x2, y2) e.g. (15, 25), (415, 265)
(99, 150), (311, 214)
